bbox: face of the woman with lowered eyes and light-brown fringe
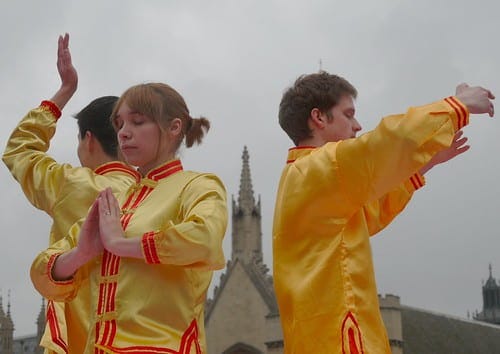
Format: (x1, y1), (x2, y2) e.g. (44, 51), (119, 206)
(115, 102), (173, 175)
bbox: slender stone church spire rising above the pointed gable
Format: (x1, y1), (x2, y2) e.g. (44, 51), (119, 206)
(231, 146), (262, 264)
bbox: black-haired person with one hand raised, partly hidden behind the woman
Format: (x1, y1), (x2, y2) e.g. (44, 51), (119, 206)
(3, 34), (139, 353)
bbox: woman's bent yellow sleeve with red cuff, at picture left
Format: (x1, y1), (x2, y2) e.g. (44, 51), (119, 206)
(30, 219), (88, 302)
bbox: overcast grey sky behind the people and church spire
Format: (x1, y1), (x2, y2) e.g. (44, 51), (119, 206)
(0, 0), (500, 336)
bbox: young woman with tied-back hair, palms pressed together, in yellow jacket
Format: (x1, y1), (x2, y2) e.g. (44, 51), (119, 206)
(31, 83), (227, 353)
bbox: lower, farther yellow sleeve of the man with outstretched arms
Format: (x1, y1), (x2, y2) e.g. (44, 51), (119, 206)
(363, 172), (425, 236)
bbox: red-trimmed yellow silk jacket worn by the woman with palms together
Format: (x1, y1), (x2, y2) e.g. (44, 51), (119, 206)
(31, 160), (227, 354)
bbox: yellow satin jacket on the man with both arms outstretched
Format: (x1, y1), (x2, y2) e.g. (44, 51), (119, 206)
(273, 97), (468, 354)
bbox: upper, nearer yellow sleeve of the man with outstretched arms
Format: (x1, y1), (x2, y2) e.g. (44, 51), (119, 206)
(335, 97), (468, 209)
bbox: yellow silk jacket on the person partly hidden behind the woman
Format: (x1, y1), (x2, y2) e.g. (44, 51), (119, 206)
(3, 101), (140, 353)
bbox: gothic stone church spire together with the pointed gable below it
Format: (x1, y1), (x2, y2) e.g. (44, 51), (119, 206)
(205, 147), (283, 354)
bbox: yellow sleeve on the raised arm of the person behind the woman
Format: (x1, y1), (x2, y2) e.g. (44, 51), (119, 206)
(2, 101), (72, 215)
